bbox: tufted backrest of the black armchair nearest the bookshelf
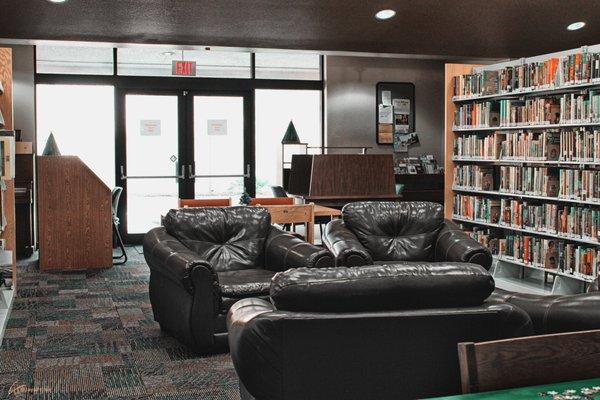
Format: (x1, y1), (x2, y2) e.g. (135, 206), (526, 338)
(342, 201), (444, 261)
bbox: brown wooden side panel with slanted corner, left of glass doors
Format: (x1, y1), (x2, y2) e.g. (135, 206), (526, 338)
(37, 156), (112, 271)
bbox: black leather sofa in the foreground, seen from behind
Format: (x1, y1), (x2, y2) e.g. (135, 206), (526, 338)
(228, 262), (532, 400)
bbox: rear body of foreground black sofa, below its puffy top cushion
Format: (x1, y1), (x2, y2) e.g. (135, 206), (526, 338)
(228, 299), (531, 400)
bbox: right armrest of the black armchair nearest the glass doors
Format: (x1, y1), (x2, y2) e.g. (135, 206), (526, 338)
(265, 226), (334, 271)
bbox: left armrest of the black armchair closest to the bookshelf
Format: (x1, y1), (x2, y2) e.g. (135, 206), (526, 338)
(323, 219), (373, 267)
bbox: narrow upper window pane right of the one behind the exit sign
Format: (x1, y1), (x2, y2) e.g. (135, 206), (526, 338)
(255, 53), (321, 81)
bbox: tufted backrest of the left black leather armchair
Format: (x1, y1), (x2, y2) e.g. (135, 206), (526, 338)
(163, 206), (271, 272)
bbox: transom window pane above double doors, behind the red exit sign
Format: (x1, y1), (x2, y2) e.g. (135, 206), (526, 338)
(117, 47), (251, 78)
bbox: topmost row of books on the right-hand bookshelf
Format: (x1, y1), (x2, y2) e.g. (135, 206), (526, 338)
(453, 51), (600, 97)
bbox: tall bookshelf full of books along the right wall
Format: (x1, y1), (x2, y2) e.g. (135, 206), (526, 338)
(444, 45), (600, 294)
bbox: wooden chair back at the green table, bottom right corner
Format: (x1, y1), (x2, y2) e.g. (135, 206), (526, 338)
(458, 330), (600, 393)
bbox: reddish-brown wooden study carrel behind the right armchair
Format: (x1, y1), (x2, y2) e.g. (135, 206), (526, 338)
(289, 154), (400, 206)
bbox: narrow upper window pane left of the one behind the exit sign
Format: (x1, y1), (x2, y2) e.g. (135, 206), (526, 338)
(36, 46), (113, 75)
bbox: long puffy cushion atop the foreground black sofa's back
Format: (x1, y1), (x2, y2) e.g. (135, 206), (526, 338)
(271, 262), (494, 312)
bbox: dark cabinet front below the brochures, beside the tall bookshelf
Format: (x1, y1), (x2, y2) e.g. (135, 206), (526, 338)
(396, 174), (444, 204)
